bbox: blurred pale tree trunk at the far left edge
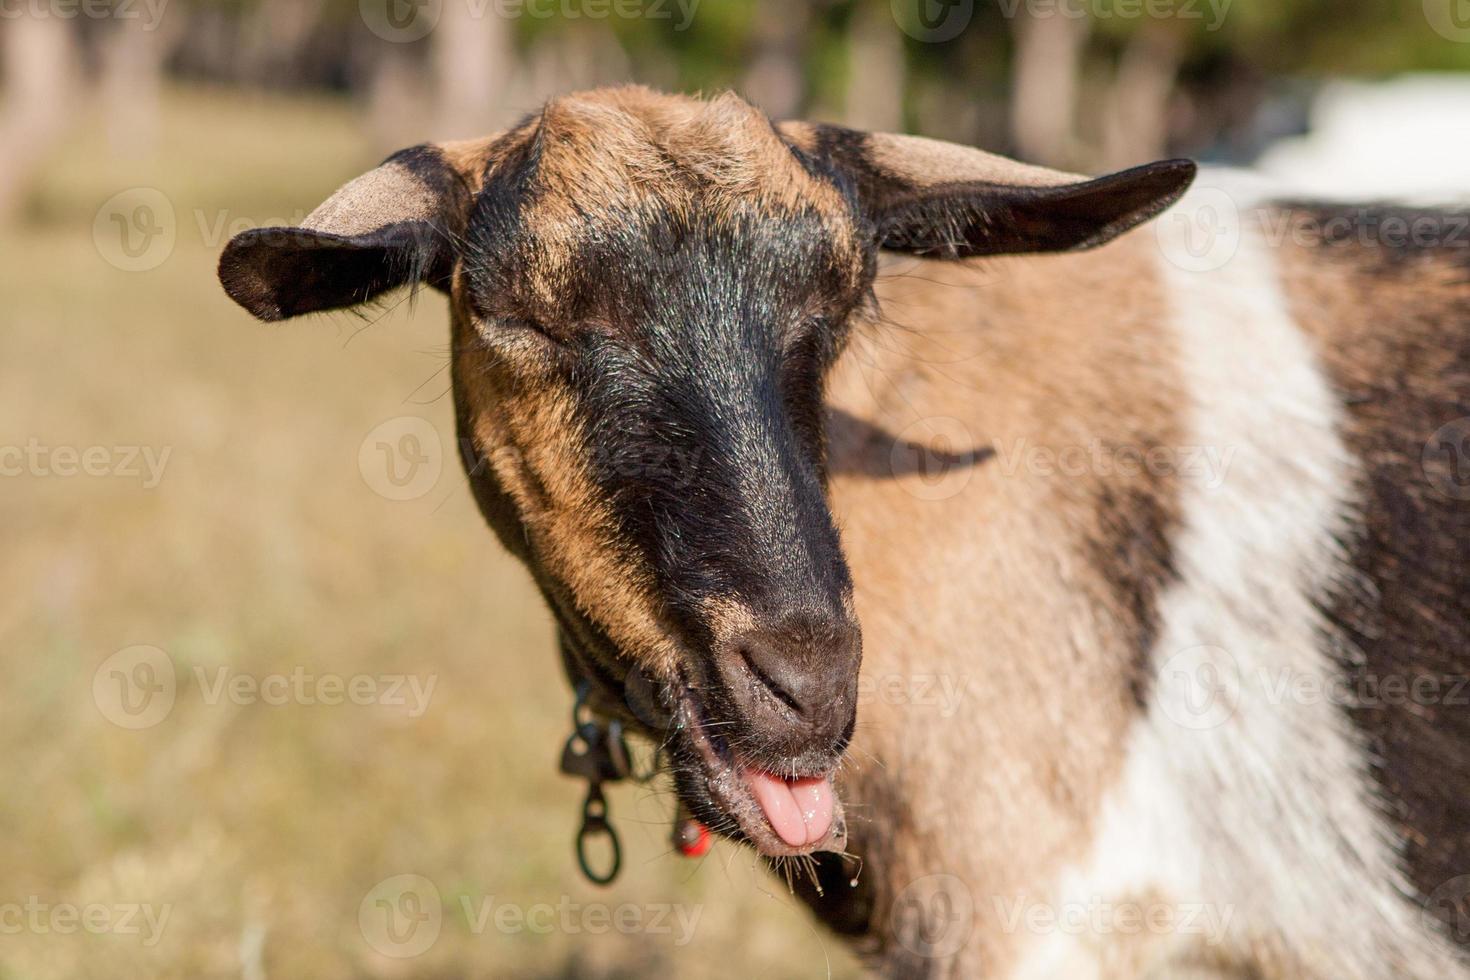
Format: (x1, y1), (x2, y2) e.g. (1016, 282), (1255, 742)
(0, 16), (81, 222)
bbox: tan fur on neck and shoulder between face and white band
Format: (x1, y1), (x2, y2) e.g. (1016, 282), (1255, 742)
(832, 238), (1182, 976)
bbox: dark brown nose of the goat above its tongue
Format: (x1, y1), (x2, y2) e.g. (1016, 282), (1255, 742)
(716, 621), (861, 736)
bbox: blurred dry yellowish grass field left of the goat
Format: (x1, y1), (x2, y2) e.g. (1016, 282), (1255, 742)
(0, 91), (856, 980)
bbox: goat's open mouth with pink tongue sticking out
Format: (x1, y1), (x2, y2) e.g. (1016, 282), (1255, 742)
(675, 686), (847, 857)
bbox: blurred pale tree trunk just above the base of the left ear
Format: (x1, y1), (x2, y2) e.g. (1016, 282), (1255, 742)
(429, 1), (517, 140)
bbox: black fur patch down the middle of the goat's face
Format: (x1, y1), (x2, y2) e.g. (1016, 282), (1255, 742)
(469, 141), (857, 639)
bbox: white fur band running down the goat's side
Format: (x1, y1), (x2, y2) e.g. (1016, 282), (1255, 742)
(1022, 172), (1467, 980)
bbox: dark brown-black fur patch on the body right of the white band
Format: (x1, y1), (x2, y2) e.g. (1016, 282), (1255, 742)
(1293, 215), (1470, 945)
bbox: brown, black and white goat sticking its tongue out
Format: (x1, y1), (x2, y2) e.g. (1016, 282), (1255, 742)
(219, 87), (1470, 980)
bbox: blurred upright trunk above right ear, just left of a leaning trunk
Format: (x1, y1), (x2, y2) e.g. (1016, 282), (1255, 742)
(1011, 4), (1092, 167)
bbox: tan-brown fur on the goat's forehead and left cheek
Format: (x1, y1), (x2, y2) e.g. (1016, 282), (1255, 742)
(441, 87), (858, 687)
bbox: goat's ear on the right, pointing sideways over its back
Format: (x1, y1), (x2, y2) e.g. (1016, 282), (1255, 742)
(781, 122), (1197, 259)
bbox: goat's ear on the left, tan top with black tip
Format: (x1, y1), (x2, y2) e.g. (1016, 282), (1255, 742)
(219, 144), (484, 320)
